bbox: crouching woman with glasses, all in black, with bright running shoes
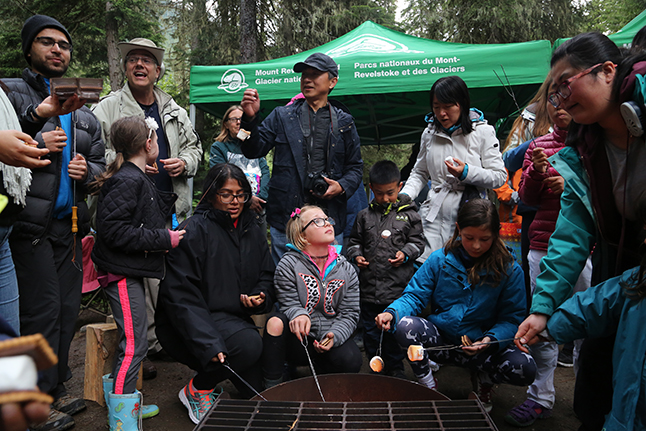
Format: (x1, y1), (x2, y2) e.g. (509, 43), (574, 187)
(156, 163), (274, 423)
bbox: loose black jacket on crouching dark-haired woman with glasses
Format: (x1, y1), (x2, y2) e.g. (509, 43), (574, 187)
(160, 202), (275, 366)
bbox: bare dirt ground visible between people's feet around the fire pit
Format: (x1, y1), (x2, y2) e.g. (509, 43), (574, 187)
(67, 311), (580, 431)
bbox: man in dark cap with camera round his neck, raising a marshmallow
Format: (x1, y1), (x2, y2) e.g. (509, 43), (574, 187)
(241, 52), (363, 264)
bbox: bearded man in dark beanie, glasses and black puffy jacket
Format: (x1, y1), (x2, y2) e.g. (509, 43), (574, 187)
(4, 15), (105, 430)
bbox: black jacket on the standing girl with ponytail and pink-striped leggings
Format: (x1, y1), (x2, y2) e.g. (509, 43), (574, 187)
(92, 162), (177, 278)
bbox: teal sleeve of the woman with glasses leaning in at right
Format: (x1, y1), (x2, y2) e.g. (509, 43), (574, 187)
(530, 147), (601, 316)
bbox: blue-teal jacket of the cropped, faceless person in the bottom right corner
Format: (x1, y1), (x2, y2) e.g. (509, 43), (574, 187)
(547, 268), (646, 431)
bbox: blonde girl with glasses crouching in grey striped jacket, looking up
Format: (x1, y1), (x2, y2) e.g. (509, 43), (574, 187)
(262, 205), (362, 388)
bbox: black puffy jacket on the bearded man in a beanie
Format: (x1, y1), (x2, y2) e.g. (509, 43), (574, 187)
(3, 69), (105, 243)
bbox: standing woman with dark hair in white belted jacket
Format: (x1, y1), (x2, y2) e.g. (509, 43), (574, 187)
(402, 76), (507, 263)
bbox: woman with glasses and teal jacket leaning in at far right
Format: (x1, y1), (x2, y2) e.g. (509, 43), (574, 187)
(516, 33), (646, 430)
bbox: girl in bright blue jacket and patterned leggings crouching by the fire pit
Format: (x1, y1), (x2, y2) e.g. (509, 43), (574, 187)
(375, 199), (536, 411)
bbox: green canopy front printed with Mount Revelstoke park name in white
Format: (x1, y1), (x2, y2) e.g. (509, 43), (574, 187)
(190, 21), (551, 104)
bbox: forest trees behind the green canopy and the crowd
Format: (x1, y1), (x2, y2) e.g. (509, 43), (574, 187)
(0, 0), (646, 190)
